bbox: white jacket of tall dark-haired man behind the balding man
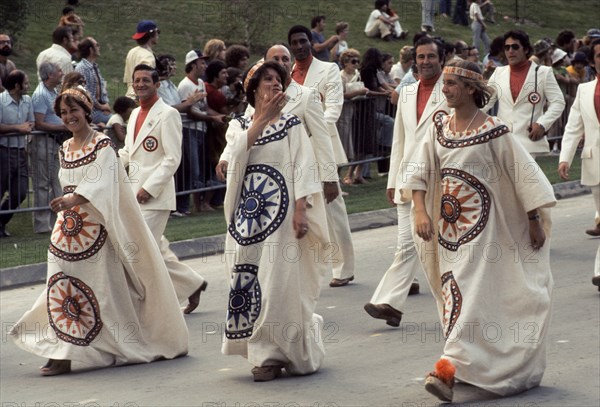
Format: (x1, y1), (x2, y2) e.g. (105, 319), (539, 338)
(296, 58), (348, 164)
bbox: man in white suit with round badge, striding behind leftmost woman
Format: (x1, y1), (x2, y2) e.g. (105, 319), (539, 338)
(119, 64), (208, 314)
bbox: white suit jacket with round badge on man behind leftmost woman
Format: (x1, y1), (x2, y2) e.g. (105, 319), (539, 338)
(119, 98), (182, 210)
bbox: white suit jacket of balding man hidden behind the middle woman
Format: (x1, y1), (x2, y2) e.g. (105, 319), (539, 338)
(220, 81), (339, 182)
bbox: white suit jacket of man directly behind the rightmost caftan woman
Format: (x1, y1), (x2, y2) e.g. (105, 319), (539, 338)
(387, 75), (450, 204)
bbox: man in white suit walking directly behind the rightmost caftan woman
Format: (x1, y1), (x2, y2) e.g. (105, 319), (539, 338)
(364, 37), (450, 326)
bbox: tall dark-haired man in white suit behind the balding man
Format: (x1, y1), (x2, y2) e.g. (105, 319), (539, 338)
(288, 25), (354, 287)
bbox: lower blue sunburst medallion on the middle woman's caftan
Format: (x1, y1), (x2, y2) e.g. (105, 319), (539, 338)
(225, 264), (262, 339)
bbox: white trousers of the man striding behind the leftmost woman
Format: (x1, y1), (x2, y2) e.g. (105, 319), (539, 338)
(142, 208), (204, 304)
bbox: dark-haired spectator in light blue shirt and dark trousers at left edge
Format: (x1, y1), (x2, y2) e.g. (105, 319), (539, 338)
(0, 70), (34, 238)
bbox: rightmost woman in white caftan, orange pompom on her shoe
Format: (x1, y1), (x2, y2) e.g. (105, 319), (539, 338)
(403, 61), (556, 401)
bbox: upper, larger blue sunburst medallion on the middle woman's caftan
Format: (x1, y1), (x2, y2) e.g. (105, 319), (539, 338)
(228, 164), (290, 246)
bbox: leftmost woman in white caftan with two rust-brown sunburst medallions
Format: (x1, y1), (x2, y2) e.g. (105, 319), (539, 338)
(10, 88), (188, 376)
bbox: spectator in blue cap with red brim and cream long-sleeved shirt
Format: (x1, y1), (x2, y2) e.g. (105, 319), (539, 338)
(123, 20), (160, 99)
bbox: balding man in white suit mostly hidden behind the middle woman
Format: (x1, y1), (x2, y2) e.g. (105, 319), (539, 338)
(216, 45), (339, 290)
